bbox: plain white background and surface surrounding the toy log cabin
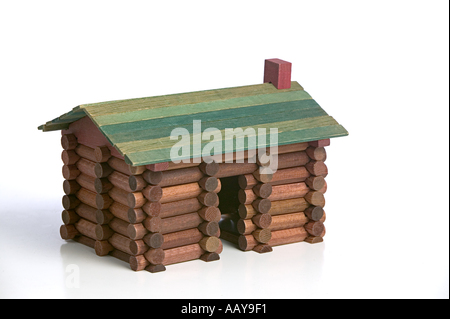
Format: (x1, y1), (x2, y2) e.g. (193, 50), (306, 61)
(0, 0), (449, 298)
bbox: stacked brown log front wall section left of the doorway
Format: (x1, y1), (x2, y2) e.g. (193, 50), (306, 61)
(144, 162), (222, 270)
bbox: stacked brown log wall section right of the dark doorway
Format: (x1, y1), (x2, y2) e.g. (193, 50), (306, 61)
(222, 141), (327, 252)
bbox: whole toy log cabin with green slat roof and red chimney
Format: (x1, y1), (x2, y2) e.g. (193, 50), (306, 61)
(39, 59), (348, 272)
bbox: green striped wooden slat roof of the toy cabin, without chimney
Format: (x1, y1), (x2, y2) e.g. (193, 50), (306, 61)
(39, 82), (348, 166)
